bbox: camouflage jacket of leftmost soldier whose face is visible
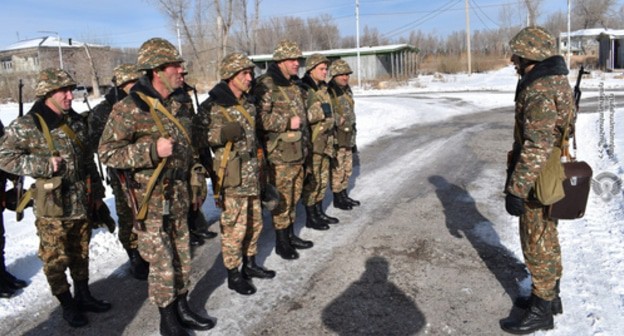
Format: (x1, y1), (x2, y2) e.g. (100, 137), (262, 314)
(0, 100), (104, 219)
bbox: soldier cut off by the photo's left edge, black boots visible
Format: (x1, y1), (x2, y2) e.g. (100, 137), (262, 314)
(0, 121), (28, 299)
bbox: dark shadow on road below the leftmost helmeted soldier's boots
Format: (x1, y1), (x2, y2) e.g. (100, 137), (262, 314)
(23, 263), (150, 336)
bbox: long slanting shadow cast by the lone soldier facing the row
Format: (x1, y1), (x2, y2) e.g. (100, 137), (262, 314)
(429, 175), (528, 300)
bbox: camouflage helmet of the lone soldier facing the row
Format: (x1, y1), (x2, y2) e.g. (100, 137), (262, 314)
(509, 26), (557, 62)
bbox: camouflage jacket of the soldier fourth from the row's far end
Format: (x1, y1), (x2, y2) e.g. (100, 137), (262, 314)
(193, 82), (260, 197)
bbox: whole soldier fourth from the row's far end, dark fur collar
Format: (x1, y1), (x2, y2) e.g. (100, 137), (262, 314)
(194, 52), (275, 295)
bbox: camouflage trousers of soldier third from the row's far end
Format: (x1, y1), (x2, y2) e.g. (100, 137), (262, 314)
(269, 164), (303, 230)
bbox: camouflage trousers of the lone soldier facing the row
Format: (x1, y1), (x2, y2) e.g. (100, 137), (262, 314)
(520, 202), (562, 301)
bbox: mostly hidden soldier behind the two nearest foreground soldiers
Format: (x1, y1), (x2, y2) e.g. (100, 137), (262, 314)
(87, 64), (149, 280)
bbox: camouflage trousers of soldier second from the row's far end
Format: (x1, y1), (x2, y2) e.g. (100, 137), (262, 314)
(301, 153), (329, 206)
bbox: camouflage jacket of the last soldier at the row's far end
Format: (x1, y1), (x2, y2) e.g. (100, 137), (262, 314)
(329, 81), (357, 147)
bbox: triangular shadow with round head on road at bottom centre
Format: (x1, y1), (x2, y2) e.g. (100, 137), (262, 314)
(322, 257), (426, 336)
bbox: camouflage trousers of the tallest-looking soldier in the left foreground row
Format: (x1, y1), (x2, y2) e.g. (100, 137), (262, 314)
(136, 180), (191, 307)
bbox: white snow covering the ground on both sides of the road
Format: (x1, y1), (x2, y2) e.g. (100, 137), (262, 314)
(0, 67), (624, 335)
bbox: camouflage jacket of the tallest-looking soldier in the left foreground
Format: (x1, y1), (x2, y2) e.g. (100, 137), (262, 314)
(98, 76), (193, 192)
